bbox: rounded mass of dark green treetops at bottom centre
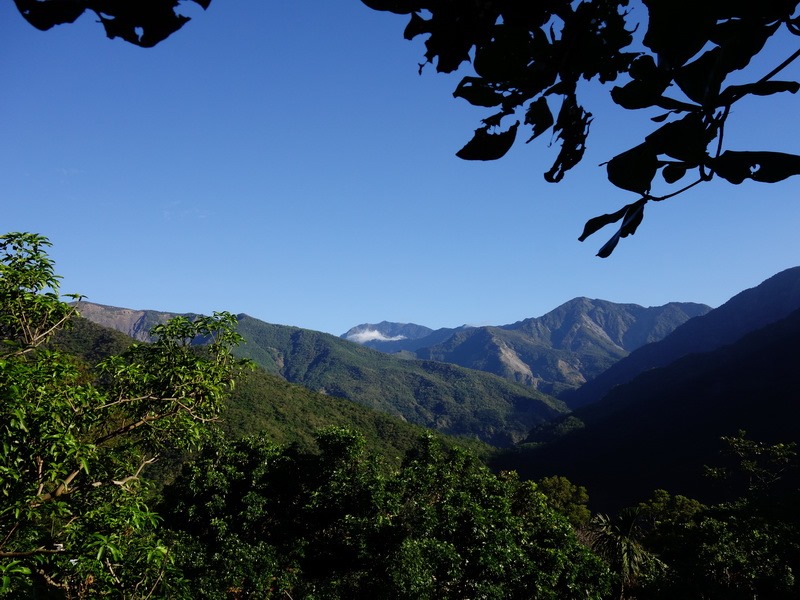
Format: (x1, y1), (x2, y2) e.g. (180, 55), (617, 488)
(164, 428), (609, 600)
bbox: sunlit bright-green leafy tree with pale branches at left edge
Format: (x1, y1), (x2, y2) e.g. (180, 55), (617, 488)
(0, 233), (244, 598)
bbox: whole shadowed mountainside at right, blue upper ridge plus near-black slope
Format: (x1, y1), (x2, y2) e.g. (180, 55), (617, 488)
(495, 268), (800, 509)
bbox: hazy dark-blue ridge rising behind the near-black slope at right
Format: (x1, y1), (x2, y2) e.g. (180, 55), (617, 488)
(561, 267), (800, 408)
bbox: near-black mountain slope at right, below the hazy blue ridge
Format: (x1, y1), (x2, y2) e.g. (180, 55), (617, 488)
(497, 310), (800, 510)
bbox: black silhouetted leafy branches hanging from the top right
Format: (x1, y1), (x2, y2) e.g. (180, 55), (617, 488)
(362, 0), (800, 257)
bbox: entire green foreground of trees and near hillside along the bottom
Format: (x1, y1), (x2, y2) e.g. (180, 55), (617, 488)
(0, 234), (800, 600)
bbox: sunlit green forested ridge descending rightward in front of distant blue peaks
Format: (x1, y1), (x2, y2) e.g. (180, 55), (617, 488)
(237, 315), (566, 446)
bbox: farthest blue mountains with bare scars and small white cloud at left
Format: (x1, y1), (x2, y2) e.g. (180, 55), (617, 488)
(342, 298), (711, 395)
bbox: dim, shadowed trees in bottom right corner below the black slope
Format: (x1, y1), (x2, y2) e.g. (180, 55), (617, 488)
(608, 432), (800, 600)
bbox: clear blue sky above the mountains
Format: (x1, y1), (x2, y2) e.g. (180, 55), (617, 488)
(0, 0), (800, 334)
